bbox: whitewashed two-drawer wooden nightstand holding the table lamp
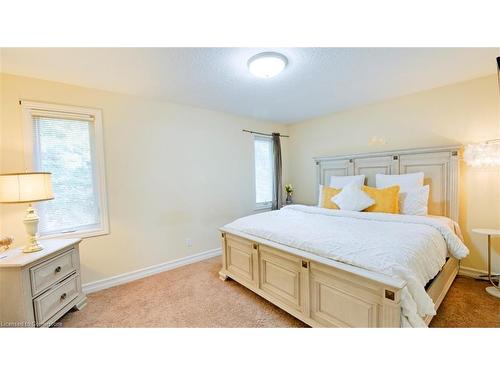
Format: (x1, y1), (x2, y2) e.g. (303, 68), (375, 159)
(0, 239), (87, 327)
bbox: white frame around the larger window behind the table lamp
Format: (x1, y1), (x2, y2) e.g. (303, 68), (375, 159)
(19, 100), (110, 239)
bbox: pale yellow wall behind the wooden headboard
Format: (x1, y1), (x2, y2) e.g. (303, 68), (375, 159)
(289, 75), (500, 271)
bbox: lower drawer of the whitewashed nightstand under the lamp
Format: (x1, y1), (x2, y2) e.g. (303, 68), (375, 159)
(33, 274), (80, 325)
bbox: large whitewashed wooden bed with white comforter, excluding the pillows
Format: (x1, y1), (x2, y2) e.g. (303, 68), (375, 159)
(219, 146), (468, 327)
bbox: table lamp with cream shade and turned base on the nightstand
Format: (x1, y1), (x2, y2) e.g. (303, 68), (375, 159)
(0, 172), (54, 253)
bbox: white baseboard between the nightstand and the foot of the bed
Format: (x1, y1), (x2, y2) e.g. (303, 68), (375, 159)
(82, 247), (222, 294)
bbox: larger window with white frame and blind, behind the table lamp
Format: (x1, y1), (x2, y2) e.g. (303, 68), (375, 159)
(22, 102), (109, 237)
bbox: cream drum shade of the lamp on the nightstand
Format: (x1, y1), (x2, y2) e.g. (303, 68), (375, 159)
(0, 172), (54, 203)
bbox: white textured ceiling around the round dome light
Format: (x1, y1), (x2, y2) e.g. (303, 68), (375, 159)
(0, 48), (500, 123)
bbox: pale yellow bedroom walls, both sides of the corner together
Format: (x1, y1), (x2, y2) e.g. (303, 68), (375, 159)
(0, 74), (500, 282)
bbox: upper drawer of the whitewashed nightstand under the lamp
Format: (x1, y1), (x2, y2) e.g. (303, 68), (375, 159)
(30, 249), (77, 296)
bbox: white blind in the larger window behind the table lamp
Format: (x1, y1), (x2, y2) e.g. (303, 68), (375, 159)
(32, 111), (102, 235)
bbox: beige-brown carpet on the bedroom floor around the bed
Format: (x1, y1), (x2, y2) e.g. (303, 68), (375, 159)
(59, 258), (500, 327)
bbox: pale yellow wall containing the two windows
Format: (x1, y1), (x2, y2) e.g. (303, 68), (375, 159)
(0, 75), (287, 283)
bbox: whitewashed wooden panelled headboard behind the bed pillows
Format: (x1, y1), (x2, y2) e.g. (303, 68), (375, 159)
(314, 146), (461, 221)
